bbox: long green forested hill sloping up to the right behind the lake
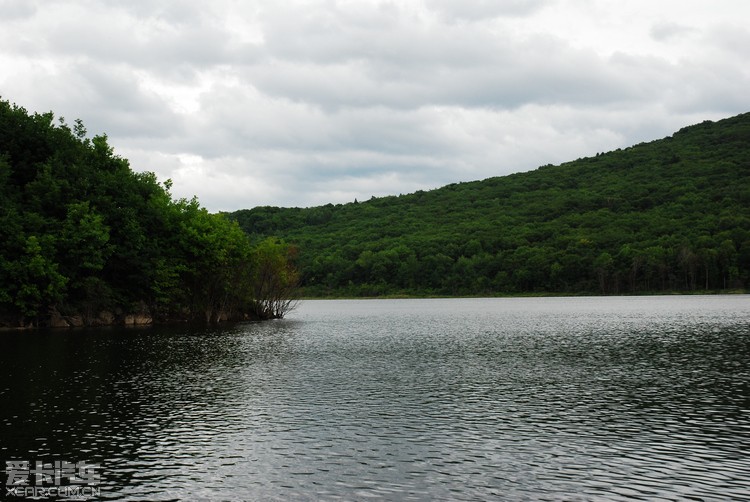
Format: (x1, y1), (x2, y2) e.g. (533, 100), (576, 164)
(231, 113), (750, 296)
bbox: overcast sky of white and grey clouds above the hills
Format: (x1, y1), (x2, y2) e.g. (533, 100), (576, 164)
(0, 0), (750, 211)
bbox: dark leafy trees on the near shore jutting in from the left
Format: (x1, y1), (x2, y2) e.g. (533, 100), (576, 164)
(0, 100), (297, 327)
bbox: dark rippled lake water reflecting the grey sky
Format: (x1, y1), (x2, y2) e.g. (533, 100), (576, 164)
(0, 296), (750, 500)
